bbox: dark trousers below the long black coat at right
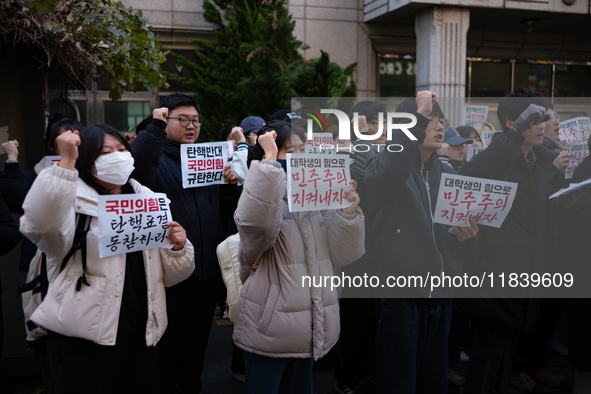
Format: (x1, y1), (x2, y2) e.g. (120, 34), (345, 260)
(464, 322), (520, 394)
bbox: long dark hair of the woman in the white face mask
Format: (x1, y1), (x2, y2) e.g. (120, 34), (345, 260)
(76, 124), (131, 195)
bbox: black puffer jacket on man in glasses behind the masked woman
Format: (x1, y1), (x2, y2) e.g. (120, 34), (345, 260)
(131, 119), (239, 281)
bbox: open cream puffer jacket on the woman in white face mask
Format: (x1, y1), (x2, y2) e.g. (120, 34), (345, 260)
(20, 165), (195, 346)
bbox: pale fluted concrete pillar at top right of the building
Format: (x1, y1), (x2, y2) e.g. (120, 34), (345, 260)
(415, 7), (470, 126)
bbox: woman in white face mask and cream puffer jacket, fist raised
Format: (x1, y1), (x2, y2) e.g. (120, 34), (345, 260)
(21, 125), (194, 394)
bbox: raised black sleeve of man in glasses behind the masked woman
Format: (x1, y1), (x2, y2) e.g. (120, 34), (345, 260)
(131, 119), (166, 189)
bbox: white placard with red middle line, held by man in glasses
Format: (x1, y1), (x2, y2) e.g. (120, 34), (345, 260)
(181, 141), (234, 189)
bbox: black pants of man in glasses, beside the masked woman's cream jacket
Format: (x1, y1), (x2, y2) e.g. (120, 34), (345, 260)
(157, 277), (219, 394)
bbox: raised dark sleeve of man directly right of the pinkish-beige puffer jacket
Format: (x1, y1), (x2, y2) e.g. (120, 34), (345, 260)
(364, 112), (429, 205)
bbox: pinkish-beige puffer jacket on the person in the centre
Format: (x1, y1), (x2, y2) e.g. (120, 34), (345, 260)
(233, 160), (365, 360)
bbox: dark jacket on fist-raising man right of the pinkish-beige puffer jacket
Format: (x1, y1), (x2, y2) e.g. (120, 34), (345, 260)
(365, 113), (475, 298)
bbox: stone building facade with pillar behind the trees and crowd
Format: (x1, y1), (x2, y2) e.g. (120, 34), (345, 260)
(67, 0), (591, 131)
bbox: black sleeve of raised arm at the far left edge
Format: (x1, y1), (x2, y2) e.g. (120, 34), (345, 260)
(0, 163), (37, 213)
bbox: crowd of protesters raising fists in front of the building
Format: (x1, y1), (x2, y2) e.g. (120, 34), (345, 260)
(0, 89), (591, 394)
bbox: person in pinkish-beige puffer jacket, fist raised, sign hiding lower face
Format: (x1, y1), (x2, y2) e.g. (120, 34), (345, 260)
(233, 121), (365, 394)
